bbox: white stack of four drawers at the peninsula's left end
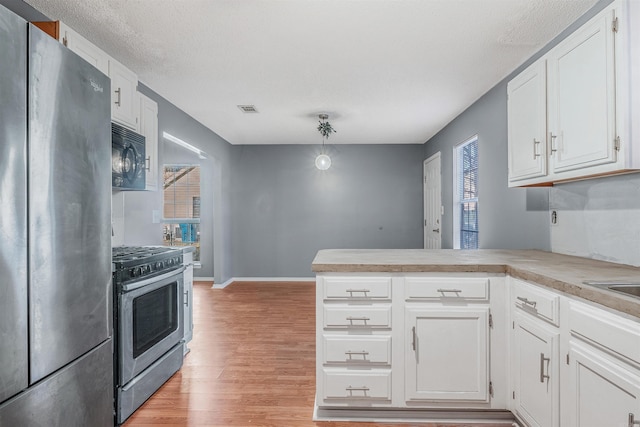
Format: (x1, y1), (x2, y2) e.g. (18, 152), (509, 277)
(316, 275), (395, 408)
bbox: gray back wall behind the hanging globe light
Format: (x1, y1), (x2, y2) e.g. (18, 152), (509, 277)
(232, 145), (423, 277)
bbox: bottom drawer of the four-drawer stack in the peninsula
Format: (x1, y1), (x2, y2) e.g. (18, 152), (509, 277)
(322, 370), (391, 404)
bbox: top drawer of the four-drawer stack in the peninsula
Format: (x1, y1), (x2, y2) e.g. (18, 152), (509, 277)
(323, 277), (391, 300)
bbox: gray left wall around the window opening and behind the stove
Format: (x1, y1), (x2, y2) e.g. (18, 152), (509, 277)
(124, 84), (234, 283)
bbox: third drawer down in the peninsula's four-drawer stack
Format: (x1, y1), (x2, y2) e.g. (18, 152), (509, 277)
(323, 335), (391, 366)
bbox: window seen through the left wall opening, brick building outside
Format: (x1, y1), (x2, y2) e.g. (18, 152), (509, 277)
(162, 165), (200, 261)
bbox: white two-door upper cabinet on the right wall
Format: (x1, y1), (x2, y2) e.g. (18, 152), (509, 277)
(507, 0), (640, 187)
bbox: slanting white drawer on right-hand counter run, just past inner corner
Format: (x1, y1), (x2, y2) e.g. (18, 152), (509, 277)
(512, 279), (560, 326)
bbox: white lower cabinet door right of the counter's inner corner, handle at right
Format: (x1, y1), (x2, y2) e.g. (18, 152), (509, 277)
(512, 313), (560, 427)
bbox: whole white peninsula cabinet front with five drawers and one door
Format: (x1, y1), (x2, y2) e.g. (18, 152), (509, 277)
(316, 273), (507, 416)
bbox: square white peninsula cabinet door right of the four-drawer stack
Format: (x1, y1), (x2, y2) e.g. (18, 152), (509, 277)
(405, 308), (489, 402)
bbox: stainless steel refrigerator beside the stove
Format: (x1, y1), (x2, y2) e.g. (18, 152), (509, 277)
(0, 6), (114, 427)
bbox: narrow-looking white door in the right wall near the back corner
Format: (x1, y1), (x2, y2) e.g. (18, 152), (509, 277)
(424, 152), (442, 249)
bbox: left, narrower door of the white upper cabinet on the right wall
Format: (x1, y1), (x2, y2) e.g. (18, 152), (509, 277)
(507, 59), (547, 182)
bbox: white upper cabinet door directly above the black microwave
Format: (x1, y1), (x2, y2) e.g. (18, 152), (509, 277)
(109, 58), (140, 131)
